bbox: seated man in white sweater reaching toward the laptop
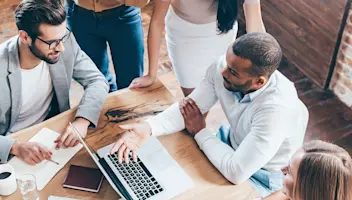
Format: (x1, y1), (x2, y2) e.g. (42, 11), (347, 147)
(111, 33), (308, 196)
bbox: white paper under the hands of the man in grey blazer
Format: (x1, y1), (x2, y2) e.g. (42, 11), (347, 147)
(9, 128), (83, 190)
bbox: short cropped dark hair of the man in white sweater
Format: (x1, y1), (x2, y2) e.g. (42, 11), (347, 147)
(232, 32), (282, 77)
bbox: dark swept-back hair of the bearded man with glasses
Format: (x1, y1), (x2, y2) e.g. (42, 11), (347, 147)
(15, 0), (66, 39)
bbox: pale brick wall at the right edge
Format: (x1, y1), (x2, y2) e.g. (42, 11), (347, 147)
(330, 6), (352, 107)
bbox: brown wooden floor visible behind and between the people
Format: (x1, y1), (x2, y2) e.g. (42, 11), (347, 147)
(0, 0), (352, 154)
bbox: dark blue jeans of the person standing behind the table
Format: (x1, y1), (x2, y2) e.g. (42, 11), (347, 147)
(65, 1), (144, 92)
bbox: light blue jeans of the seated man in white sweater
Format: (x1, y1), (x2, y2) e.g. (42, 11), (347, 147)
(216, 126), (283, 197)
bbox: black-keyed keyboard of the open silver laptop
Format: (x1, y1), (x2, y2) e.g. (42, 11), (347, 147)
(108, 152), (164, 200)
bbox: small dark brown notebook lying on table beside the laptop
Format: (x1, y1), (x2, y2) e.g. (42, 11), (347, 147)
(63, 165), (103, 193)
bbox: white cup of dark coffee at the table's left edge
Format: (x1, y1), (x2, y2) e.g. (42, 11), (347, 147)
(0, 164), (17, 196)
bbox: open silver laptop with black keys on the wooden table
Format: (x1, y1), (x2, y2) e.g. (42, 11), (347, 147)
(70, 123), (193, 200)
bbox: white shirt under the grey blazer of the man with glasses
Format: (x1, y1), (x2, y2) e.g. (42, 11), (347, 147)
(10, 61), (54, 132)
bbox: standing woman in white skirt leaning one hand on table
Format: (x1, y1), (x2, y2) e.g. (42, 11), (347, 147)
(130, 0), (265, 96)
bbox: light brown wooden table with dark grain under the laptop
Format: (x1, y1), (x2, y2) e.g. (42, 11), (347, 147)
(0, 81), (258, 200)
